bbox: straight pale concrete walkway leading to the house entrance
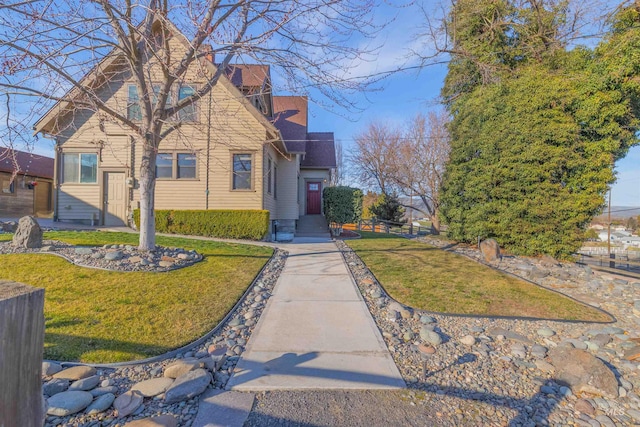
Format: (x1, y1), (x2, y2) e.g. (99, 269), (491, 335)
(227, 238), (405, 391)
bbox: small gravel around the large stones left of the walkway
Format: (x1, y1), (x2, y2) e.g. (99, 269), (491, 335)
(43, 249), (287, 427)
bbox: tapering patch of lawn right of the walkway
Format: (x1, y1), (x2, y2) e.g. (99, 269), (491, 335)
(346, 232), (612, 321)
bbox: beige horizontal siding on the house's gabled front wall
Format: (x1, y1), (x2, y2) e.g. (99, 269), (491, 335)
(58, 32), (281, 224)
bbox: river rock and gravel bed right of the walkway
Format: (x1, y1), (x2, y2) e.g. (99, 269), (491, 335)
(337, 238), (640, 427)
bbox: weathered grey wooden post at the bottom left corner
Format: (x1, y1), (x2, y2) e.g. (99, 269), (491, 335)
(0, 280), (44, 427)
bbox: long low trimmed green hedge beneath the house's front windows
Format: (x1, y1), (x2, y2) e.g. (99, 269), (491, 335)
(133, 209), (269, 240)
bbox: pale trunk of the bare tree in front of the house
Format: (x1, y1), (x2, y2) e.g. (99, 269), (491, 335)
(139, 142), (156, 251)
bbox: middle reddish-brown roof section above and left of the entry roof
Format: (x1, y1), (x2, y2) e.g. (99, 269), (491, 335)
(272, 96), (307, 153)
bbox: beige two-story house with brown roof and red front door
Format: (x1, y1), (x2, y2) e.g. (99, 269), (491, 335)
(34, 20), (336, 237)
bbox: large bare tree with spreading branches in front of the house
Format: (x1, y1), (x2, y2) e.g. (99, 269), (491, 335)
(0, 0), (377, 250)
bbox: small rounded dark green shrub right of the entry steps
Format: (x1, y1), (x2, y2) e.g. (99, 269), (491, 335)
(322, 186), (362, 234)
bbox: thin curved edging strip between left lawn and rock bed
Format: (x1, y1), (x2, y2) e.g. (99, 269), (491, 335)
(43, 248), (288, 368)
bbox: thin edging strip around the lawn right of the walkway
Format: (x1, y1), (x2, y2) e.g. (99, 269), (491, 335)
(337, 236), (618, 325)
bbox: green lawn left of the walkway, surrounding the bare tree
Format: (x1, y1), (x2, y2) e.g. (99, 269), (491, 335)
(0, 232), (273, 363)
